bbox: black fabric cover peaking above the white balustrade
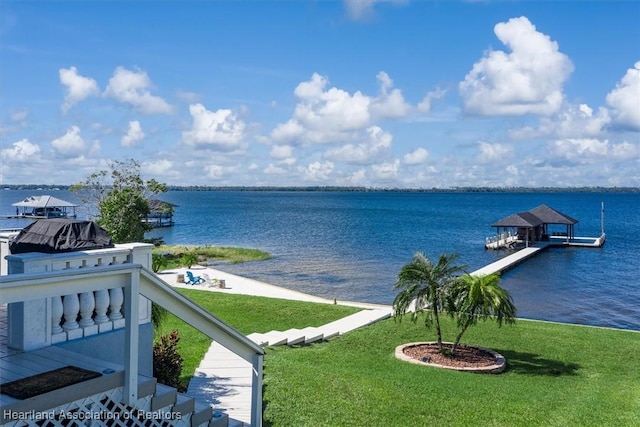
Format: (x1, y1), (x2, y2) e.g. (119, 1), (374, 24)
(9, 219), (113, 254)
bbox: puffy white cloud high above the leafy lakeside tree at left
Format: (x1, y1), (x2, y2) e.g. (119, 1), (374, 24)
(104, 67), (172, 114)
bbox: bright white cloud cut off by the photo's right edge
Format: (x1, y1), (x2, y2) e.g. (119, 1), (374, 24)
(607, 61), (640, 130)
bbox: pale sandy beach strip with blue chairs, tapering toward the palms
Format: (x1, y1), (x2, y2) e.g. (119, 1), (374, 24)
(157, 265), (389, 308)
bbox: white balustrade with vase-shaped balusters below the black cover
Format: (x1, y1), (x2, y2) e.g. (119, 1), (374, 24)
(6, 244), (153, 350)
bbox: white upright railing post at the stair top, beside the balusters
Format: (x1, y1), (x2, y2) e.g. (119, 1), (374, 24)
(123, 270), (140, 406)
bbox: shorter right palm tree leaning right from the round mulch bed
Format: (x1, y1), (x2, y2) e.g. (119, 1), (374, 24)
(447, 273), (516, 355)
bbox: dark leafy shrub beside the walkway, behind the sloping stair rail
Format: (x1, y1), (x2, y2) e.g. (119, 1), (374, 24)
(153, 329), (186, 392)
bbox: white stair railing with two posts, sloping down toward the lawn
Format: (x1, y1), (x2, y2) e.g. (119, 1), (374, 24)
(0, 262), (264, 427)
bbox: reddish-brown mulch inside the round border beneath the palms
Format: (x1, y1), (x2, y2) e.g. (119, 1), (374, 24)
(404, 344), (496, 368)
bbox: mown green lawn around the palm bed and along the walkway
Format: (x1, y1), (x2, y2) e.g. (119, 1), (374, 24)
(155, 290), (640, 426)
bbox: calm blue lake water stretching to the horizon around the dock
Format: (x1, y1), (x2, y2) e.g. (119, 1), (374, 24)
(0, 191), (640, 330)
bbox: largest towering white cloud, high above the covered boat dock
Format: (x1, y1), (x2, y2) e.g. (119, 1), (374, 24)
(459, 16), (573, 115)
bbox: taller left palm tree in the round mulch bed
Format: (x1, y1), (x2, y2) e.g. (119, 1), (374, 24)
(393, 252), (463, 352)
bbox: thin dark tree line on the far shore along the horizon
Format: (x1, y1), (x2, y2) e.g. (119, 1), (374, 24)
(2, 184), (640, 193)
